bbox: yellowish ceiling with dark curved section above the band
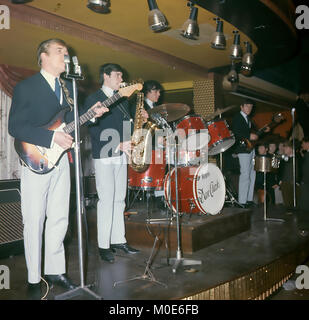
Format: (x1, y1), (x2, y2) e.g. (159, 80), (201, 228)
(0, 0), (296, 89)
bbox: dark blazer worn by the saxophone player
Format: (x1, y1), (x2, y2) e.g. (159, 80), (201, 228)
(84, 89), (133, 159)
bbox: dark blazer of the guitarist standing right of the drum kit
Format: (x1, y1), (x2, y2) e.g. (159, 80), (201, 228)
(231, 112), (255, 153)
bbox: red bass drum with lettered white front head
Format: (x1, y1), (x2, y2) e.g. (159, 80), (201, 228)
(164, 163), (225, 215)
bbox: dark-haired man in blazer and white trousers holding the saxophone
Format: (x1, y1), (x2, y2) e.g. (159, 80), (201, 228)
(85, 63), (143, 263)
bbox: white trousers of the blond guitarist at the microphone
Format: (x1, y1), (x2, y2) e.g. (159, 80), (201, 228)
(21, 155), (70, 283)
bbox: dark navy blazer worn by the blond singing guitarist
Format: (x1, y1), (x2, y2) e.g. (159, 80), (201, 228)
(8, 72), (74, 147)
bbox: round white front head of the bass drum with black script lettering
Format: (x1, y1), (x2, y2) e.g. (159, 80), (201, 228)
(193, 163), (225, 215)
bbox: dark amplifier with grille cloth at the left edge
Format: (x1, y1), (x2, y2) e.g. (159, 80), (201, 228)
(0, 188), (24, 259)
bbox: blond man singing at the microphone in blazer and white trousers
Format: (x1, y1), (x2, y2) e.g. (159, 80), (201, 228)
(9, 39), (108, 294)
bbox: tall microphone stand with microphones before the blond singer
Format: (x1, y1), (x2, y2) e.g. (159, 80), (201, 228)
(55, 57), (103, 300)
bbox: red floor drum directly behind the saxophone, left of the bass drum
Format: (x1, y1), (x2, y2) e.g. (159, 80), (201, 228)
(128, 149), (166, 190)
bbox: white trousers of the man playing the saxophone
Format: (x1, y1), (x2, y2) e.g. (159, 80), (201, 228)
(94, 154), (127, 249)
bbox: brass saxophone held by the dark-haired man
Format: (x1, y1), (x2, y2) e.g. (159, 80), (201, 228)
(130, 92), (158, 172)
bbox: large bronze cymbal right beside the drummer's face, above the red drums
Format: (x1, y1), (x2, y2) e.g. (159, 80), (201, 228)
(148, 103), (190, 122)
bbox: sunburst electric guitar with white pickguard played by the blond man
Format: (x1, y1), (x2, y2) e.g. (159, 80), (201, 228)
(14, 83), (143, 174)
